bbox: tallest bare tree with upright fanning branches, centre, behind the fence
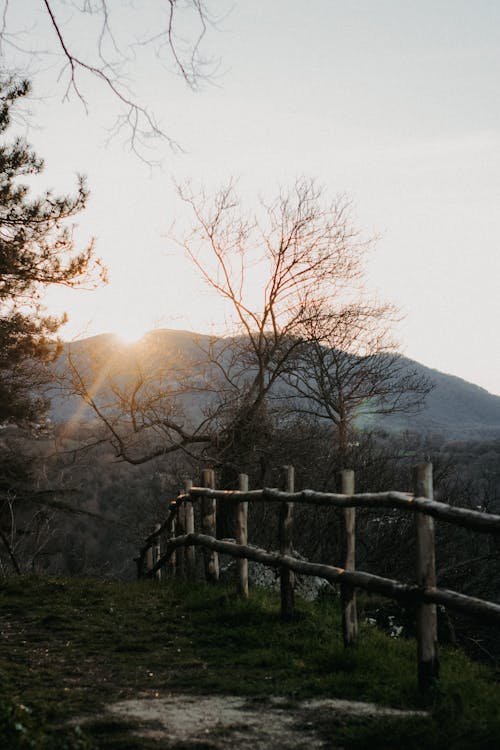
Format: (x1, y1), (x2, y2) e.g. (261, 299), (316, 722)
(179, 179), (370, 488)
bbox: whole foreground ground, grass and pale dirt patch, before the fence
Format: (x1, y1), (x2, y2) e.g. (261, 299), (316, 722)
(0, 576), (500, 750)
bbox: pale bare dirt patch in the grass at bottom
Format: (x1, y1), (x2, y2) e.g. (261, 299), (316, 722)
(107, 694), (425, 750)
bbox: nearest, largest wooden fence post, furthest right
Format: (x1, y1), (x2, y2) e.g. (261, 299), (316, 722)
(413, 463), (439, 691)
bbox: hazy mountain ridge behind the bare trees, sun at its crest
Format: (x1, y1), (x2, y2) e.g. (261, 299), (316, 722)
(50, 329), (500, 440)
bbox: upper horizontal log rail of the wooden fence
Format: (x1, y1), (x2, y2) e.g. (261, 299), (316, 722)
(182, 487), (500, 535)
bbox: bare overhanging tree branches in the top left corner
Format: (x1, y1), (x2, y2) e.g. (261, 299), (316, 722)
(0, 0), (217, 158)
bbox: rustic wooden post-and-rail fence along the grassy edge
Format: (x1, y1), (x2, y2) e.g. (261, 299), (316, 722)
(136, 463), (500, 691)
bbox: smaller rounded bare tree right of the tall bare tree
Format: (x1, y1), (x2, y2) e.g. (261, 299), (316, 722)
(287, 298), (433, 469)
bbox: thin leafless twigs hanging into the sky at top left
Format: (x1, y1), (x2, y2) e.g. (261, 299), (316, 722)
(0, 0), (217, 163)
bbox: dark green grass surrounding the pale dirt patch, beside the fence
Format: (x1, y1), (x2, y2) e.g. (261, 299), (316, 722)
(0, 577), (500, 750)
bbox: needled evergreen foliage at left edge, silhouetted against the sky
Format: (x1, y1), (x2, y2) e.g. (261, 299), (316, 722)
(0, 76), (100, 424)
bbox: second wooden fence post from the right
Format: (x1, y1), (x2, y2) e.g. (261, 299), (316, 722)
(340, 469), (358, 646)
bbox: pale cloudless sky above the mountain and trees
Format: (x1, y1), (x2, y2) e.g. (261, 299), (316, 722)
(2, 0), (500, 395)
